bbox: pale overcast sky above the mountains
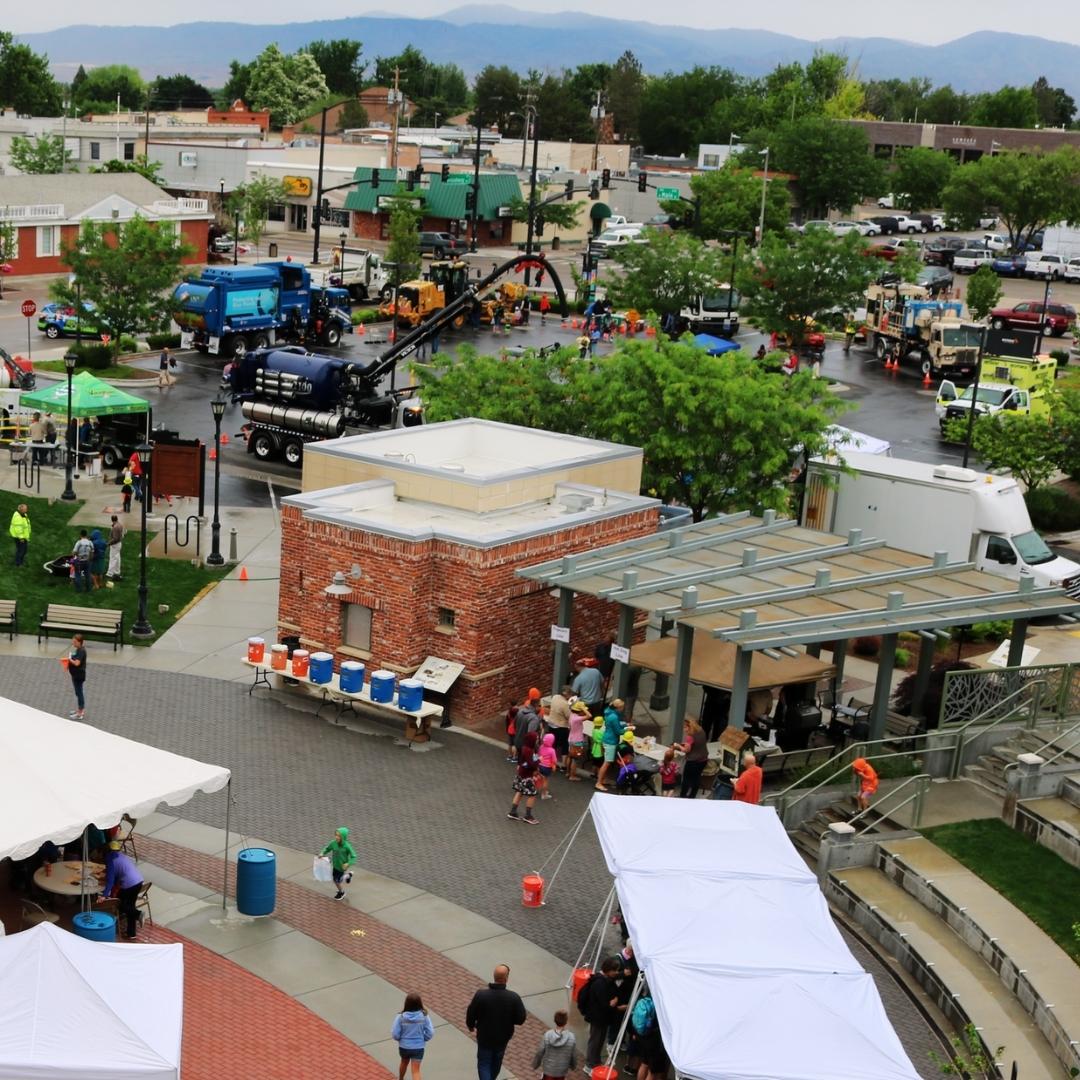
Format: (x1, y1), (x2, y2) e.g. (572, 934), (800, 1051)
(3, 0), (1080, 43)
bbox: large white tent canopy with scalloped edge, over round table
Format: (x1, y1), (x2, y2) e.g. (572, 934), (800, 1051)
(0, 698), (229, 859)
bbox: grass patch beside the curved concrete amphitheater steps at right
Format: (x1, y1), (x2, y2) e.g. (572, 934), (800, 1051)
(922, 818), (1080, 963)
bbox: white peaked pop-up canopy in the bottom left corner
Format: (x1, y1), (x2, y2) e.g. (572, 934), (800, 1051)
(0, 922), (184, 1080)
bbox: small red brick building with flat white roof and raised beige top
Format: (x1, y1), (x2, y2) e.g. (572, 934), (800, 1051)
(278, 420), (659, 724)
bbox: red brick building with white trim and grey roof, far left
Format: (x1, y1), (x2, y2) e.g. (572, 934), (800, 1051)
(0, 173), (214, 274)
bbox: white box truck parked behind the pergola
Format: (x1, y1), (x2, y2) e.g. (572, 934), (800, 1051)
(802, 453), (1080, 598)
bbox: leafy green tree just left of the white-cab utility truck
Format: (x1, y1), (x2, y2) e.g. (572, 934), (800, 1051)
(737, 229), (876, 348)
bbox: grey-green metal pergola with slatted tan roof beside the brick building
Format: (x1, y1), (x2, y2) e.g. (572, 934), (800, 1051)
(517, 510), (1080, 739)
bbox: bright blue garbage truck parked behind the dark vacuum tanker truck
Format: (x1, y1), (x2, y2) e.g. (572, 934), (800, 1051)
(172, 261), (352, 360)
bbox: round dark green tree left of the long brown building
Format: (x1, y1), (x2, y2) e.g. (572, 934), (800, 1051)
(770, 116), (882, 217)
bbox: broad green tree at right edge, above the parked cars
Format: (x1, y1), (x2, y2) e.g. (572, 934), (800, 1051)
(942, 147), (1080, 251)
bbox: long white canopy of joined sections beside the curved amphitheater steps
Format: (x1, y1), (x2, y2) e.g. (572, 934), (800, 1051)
(590, 795), (918, 1080)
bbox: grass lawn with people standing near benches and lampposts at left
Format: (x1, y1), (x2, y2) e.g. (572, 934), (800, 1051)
(0, 491), (224, 656)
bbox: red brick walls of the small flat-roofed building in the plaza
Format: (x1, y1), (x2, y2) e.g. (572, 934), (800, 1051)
(278, 507), (657, 724)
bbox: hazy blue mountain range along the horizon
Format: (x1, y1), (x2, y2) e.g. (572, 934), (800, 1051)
(19, 4), (1080, 99)
